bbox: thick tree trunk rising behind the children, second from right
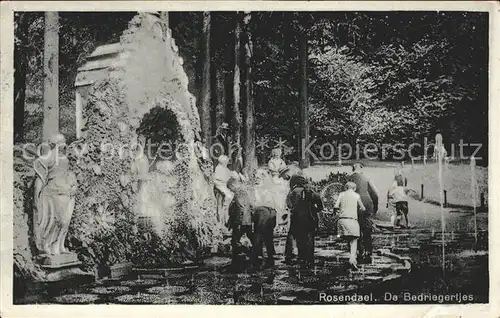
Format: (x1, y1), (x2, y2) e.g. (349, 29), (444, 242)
(243, 12), (257, 176)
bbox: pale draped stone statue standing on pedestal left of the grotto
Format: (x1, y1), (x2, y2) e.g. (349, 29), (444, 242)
(33, 134), (77, 257)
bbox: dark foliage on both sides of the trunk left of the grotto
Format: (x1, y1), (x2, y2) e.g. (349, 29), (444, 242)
(14, 12), (134, 142)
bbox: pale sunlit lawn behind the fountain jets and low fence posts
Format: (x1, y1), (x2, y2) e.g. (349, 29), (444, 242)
(304, 161), (488, 232)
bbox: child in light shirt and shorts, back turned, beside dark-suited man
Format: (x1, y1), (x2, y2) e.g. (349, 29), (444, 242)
(335, 182), (366, 269)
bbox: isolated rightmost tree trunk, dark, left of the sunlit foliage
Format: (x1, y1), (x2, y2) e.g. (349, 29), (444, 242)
(299, 19), (310, 168)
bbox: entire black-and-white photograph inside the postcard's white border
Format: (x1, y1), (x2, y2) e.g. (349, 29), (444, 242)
(2, 0), (496, 317)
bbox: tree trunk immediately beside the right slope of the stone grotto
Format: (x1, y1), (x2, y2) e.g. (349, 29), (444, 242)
(199, 11), (212, 148)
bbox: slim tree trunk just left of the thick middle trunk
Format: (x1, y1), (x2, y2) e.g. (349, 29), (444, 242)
(232, 13), (242, 150)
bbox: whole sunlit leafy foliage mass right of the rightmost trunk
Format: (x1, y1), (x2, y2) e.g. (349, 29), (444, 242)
(310, 25), (476, 157)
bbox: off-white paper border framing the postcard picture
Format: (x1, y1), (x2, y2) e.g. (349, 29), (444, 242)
(0, 1), (500, 318)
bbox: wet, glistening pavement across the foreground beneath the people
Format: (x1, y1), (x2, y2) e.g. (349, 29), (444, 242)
(20, 225), (488, 304)
